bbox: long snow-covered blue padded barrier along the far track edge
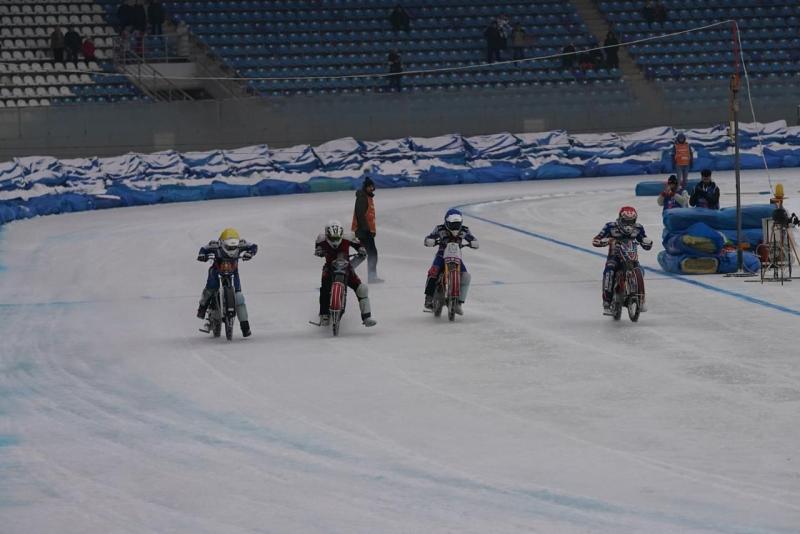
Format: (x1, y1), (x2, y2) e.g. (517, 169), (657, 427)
(0, 121), (800, 223)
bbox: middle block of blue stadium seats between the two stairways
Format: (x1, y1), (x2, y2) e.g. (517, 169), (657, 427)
(156, 0), (629, 96)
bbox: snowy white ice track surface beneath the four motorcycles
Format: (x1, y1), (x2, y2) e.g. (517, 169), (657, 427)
(0, 170), (800, 534)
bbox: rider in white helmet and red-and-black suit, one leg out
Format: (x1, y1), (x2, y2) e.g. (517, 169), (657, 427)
(314, 220), (376, 326)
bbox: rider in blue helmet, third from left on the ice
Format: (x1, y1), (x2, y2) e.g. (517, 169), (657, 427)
(425, 208), (478, 315)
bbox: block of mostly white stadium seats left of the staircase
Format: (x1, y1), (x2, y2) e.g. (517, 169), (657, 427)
(0, 0), (145, 108)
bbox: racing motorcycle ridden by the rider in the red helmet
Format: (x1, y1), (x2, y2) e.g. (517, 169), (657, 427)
(611, 239), (644, 322)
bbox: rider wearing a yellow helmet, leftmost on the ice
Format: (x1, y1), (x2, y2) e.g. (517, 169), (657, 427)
(197, 228), (258, 337)
